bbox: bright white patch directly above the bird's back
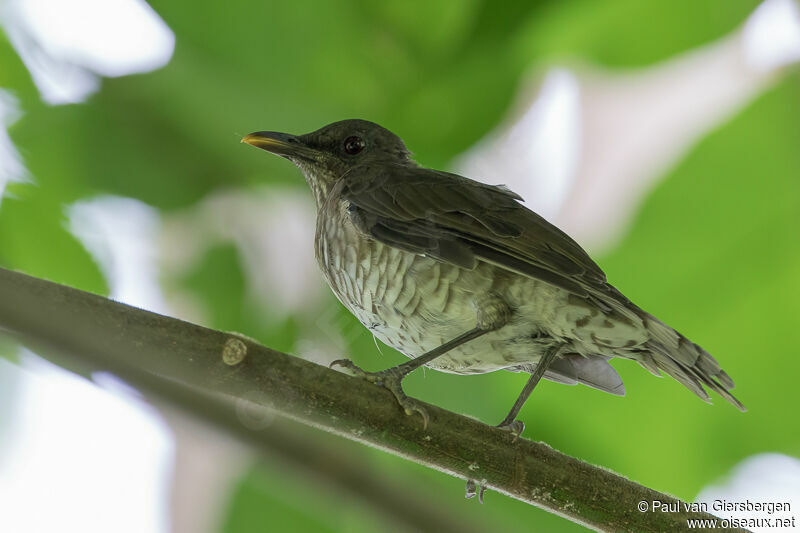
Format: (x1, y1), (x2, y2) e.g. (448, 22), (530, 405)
(455, 68), (581, 217)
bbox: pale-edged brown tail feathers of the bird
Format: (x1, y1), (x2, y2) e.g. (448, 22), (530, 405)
(636, 313), (747, 411)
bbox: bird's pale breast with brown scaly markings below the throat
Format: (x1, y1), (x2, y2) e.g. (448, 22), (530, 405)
(316, 200), (476, 355)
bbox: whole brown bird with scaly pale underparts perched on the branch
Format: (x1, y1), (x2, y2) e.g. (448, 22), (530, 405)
(242, 119), (745, 436)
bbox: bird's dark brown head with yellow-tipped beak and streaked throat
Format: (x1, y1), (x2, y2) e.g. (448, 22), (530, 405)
(242, 119), (414, 207)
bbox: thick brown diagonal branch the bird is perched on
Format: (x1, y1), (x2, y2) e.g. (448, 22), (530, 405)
(0, 269), (742, 532)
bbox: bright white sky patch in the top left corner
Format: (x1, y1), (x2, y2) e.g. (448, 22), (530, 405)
(0, 0), (175, 105)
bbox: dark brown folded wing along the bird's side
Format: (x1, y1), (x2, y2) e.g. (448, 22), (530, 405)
(340, 165), (629, 308)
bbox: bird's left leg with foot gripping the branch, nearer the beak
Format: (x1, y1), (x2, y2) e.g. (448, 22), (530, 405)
(330, 297), (511, 428)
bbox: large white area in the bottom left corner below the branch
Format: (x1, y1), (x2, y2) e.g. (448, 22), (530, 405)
(0, 356), (173, 533)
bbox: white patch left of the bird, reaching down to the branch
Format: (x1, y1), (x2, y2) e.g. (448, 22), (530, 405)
(67, 196), (168, 313)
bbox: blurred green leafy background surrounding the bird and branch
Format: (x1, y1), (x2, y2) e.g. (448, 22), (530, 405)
(0, 0), (800, 533)
